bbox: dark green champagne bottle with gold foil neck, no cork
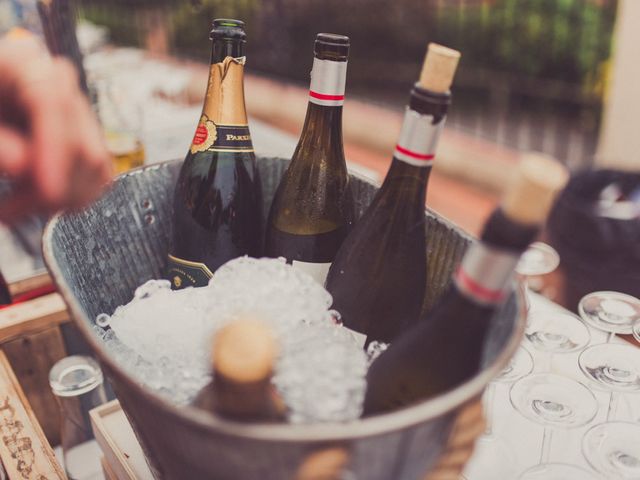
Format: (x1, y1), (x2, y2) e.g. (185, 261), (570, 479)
(167, 19), (262, 289)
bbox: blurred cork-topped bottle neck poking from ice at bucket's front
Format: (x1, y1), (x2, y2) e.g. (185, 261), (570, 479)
(194, 319), (285, 422)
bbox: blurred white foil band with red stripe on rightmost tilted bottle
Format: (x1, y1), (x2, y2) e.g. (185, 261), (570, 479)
(454, 242), (519, 305)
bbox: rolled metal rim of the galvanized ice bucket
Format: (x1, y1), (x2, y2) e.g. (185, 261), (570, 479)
(42, 160), (526, 442)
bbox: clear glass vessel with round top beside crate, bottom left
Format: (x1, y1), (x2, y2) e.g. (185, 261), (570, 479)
(49, 355), (107, 480)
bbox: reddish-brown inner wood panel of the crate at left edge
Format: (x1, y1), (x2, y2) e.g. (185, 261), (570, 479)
(2, 325), (67, 445)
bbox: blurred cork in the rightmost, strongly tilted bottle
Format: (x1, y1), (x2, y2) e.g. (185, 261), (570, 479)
(502, 152), (569, 225)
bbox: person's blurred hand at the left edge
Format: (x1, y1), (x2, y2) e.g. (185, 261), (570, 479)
(0, 39), (111, 221)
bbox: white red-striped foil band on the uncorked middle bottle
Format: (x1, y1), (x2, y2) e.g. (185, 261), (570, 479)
(309, 57), (347, 107)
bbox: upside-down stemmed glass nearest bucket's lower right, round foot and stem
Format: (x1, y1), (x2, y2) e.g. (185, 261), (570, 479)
(509, 373), (598, 480)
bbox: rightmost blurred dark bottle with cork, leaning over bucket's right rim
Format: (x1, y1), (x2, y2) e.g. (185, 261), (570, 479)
(364, 154), (568, 415)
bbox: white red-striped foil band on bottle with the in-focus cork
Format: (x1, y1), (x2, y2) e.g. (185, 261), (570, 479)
(393, 107), (444, 167)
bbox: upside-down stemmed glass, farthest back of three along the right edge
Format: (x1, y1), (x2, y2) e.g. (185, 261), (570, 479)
(578, 291), (640, 343)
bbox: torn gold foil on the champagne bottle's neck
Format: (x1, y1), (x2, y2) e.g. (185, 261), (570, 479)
(203, 57), (247, 126)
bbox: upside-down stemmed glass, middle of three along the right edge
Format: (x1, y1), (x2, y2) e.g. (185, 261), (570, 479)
(578, 343), (640, 420)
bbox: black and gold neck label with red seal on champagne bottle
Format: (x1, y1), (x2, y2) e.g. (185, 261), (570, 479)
(191, 115), (253, 153)
